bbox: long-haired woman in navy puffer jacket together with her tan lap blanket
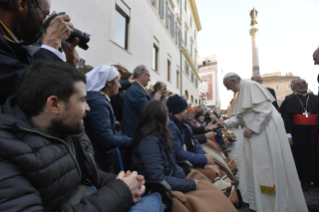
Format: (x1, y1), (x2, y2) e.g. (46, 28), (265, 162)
(131, 100), (237, 212)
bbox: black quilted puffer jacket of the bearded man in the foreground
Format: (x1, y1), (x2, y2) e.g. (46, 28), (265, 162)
(0, 98), (132, 212)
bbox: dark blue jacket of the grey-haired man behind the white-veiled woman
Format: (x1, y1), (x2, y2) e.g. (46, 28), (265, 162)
(122, 82), (150, 137)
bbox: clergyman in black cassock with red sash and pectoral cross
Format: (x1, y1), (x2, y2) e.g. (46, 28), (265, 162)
(279, 79), (319, 190)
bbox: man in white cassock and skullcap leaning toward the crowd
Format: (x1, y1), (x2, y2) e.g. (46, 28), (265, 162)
(221, 73), (308, 212)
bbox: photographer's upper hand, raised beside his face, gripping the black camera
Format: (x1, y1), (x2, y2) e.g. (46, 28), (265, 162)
(42, 11), (73, 50)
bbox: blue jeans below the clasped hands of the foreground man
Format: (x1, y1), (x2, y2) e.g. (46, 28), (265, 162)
(130, 193), (164, 212)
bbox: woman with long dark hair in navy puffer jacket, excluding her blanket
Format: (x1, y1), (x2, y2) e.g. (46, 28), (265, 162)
(132, 100), (197, 192)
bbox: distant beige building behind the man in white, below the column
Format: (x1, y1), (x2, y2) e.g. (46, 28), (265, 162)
(261, 72), (300, 106)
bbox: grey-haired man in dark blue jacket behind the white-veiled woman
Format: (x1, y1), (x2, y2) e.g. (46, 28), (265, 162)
(122, 65), (161, 138)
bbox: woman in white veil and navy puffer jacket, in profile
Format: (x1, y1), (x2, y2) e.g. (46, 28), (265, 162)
(84, 65), (131, 172)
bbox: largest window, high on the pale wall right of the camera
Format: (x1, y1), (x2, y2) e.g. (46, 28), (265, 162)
(114, 5), (130, 49)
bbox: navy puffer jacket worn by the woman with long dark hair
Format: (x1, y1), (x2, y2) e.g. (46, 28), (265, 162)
(132, 136), (196, 192)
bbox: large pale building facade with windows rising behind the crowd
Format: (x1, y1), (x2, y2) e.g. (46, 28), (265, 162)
(51, 0), (201, 104)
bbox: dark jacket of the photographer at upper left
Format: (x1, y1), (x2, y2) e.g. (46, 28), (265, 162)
(0, 24), (62, 105)
